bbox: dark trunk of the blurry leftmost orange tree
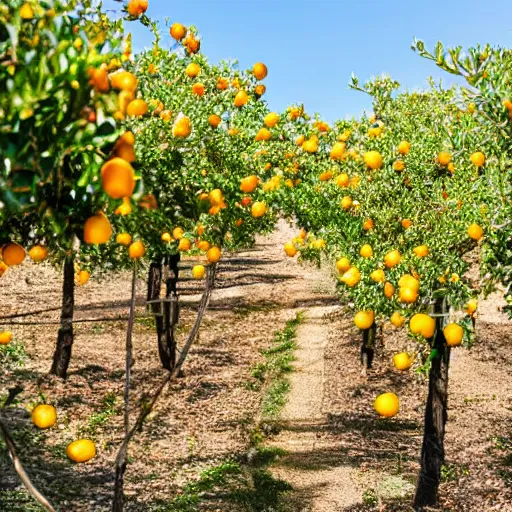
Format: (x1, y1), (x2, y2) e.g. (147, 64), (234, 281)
(50, 256), (75, 379)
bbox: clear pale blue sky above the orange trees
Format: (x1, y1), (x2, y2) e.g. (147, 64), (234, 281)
(105, 0), (512, 122)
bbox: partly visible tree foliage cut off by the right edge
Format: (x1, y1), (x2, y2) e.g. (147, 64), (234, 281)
(413, 40), (512, 313)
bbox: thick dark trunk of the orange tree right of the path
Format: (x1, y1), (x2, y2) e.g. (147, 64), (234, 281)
(414, 301), (450, 512)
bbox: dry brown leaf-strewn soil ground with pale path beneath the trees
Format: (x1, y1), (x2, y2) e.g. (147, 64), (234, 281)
(0, 224), (512, 512)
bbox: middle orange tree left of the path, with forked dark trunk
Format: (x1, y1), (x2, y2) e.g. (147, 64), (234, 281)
(97, 23), (280, 370)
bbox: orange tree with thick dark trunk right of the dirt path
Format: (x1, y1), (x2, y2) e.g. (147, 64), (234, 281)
(278, 77), (494, 508)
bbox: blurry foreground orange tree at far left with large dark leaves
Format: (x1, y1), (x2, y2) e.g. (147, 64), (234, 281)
(0, 0), (150, 377)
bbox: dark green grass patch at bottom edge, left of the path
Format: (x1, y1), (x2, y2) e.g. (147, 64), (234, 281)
(151, 448), (291, 512)
